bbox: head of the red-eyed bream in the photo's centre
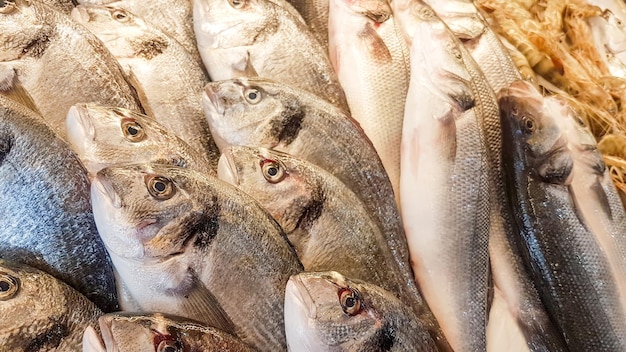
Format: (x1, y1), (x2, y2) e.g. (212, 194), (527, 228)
(217, 146), (324, 236)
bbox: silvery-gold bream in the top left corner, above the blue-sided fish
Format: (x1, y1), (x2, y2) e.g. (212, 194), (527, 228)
(0, 0), (145, 138)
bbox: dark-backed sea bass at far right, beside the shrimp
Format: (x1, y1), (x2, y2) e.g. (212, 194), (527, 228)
(498, 81), (626, 351)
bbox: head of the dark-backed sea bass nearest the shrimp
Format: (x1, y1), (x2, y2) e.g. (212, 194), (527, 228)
(498, 81), (573, 184)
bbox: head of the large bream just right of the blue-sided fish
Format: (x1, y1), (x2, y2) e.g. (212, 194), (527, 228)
(91, 164), (204, 260)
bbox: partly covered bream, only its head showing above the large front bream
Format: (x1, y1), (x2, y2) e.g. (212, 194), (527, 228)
(65, 104), (216, 179)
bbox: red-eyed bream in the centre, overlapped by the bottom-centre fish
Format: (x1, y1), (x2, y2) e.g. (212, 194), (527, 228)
(218, 146), (412, 296)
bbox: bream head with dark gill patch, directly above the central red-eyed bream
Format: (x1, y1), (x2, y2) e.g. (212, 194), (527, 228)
(202, 78), (304, 150)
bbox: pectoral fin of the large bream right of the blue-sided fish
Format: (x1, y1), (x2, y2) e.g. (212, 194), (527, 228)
(182, 271), (237, 336)
